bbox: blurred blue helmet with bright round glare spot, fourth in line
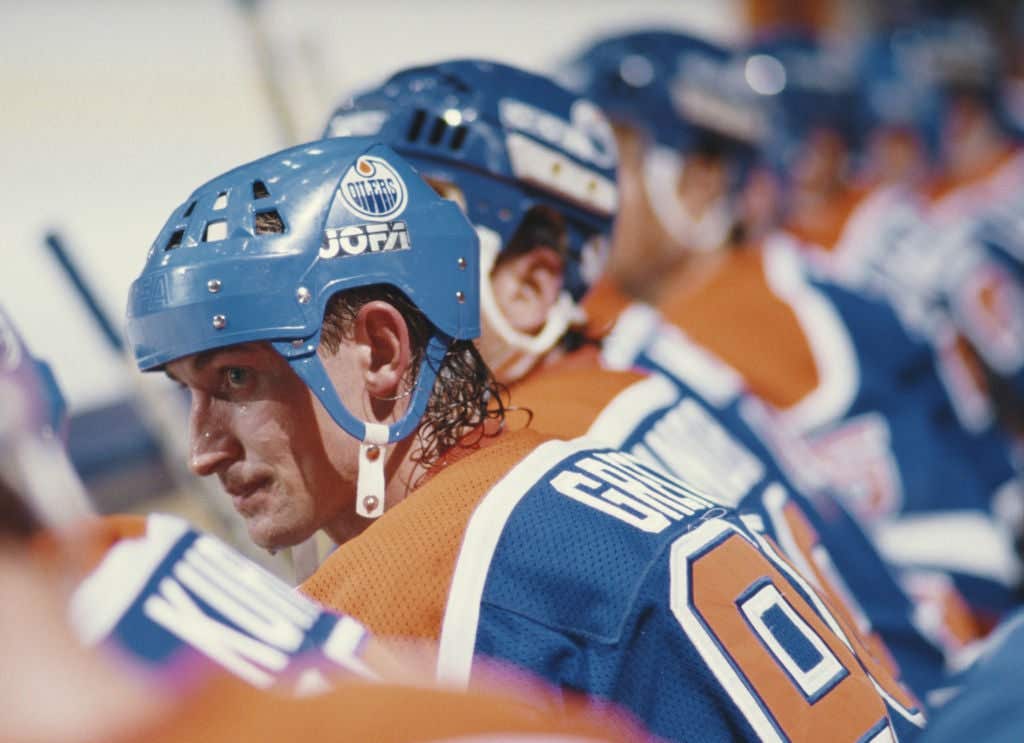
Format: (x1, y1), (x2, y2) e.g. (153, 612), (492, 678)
(743, 31), (860, 173)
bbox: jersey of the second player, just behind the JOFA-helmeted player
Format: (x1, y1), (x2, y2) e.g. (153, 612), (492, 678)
(511, 337), (946, 696)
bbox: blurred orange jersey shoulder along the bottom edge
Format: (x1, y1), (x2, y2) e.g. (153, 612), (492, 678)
(94, 678), (645, 743)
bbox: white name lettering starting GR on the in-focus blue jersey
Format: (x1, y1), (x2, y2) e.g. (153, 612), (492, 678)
(550, 451), (724, 534)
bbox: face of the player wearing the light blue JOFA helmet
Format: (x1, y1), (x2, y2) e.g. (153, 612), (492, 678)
(167, 344), (357, 549)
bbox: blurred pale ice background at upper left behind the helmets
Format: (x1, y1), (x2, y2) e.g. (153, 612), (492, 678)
(0, 0), (741, 411)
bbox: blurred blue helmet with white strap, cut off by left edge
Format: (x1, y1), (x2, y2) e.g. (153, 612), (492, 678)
(0, 309), (91, 526)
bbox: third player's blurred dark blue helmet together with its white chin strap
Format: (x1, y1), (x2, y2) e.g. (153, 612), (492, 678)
(563, 31), (767, 251)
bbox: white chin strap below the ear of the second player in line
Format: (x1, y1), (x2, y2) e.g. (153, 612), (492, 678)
(476, 226), (586, 384)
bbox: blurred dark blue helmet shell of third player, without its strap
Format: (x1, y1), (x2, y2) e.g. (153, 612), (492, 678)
(563, 31), (765, 162)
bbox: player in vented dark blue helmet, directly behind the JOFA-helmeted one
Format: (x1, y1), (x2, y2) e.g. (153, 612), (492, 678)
(328, 56), (941, 690)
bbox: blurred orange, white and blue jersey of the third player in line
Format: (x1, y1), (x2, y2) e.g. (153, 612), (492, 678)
(662, 202), (1024, 630)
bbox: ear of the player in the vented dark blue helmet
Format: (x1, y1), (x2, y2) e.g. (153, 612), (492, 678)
(490, 246), (564, 333)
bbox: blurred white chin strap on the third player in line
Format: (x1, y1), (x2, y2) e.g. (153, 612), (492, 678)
(643, 146), (731, 253)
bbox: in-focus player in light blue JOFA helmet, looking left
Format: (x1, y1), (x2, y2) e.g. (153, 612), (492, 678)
(128, 137), (920, 740)
